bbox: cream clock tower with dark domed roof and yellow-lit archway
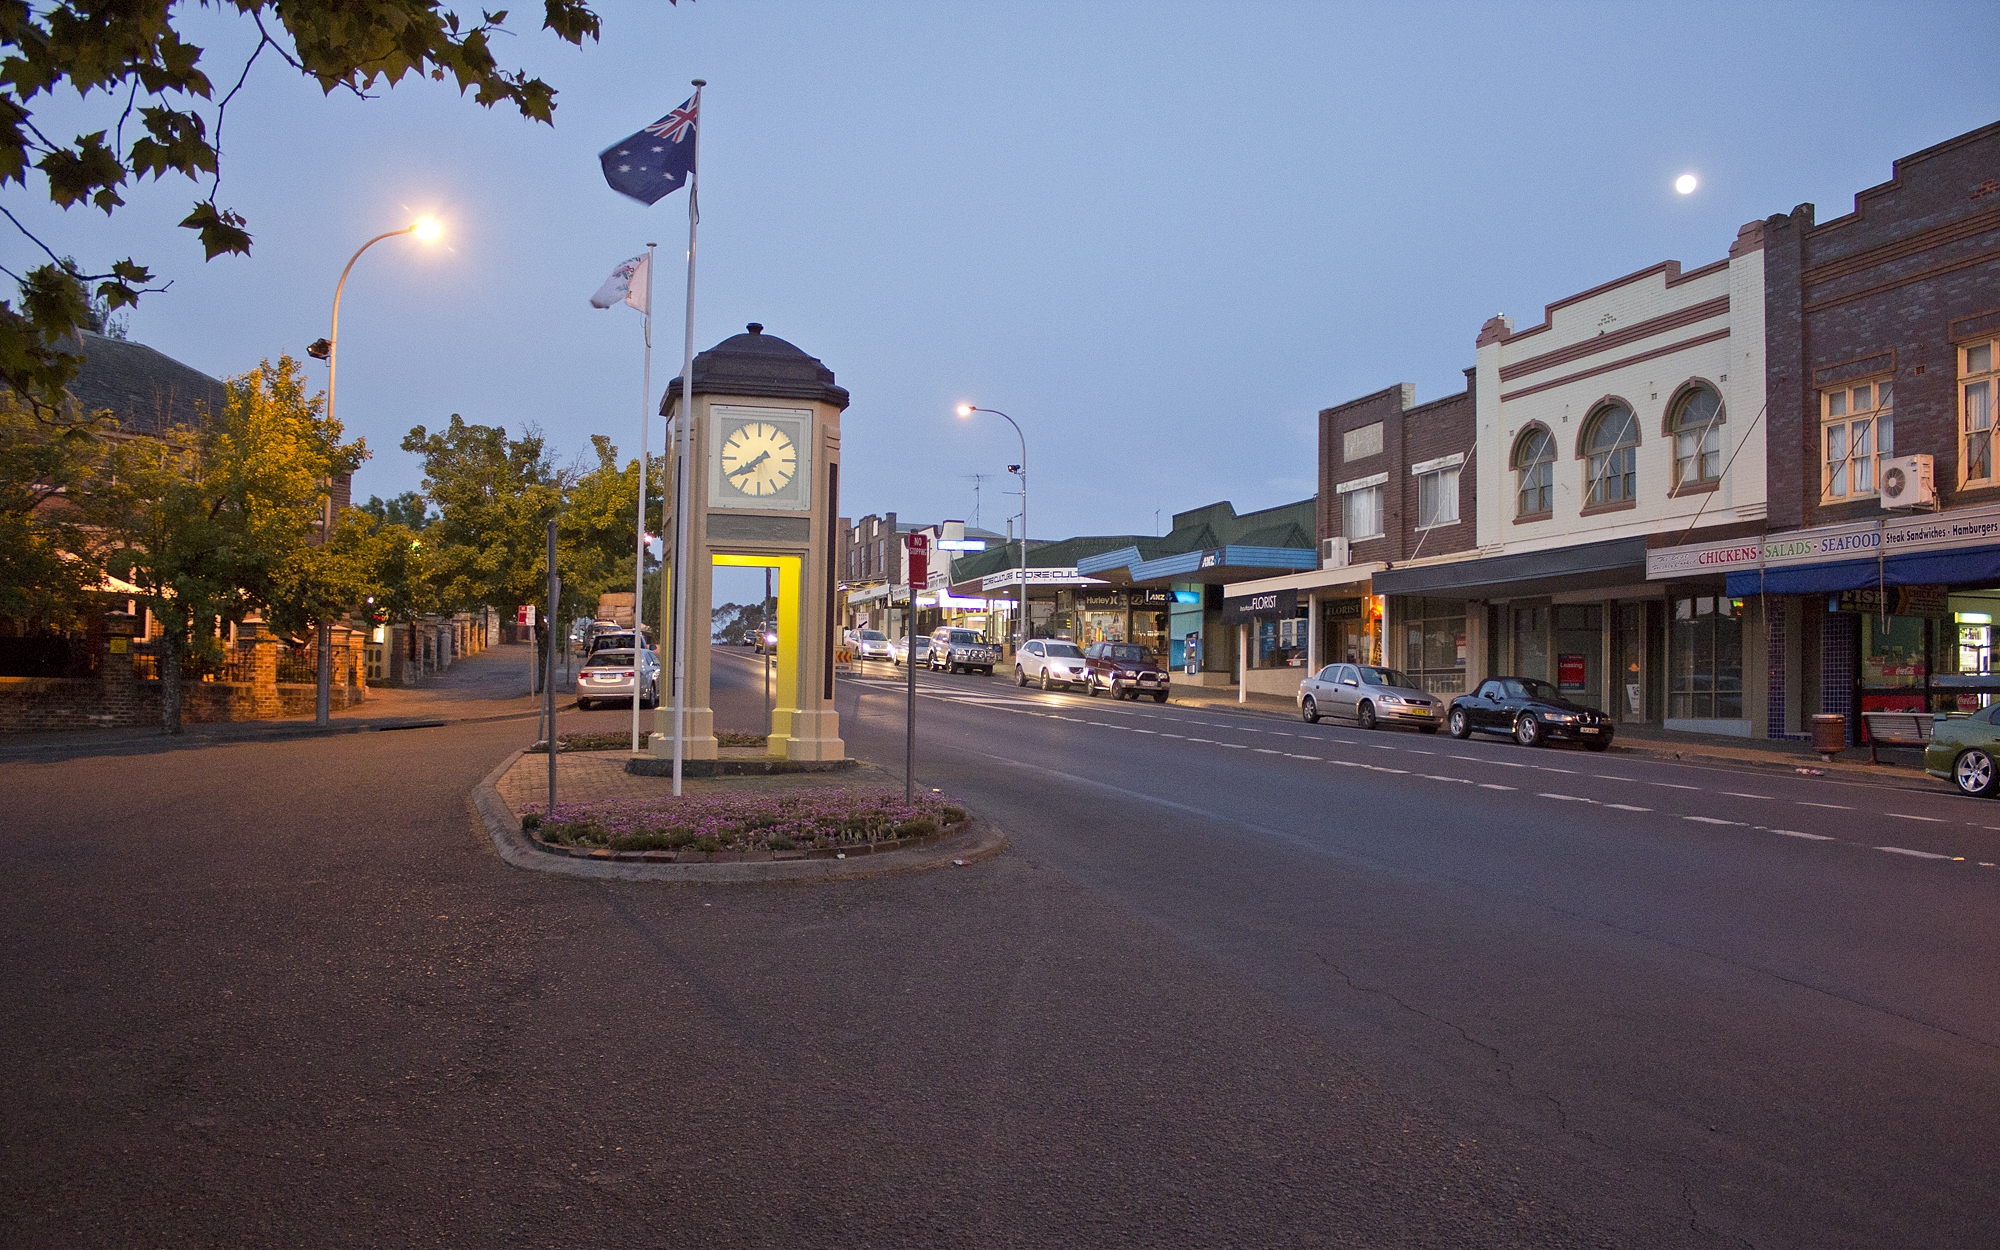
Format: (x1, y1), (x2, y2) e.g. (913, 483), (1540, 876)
(652, 322), (848, 760)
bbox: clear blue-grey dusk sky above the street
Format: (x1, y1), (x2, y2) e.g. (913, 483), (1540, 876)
(15, 0), (2000, 552)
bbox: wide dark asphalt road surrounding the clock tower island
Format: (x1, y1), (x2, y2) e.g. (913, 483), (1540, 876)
(0, 648), (2000, 1246)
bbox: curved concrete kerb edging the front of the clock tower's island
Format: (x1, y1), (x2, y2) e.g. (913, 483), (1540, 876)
(472, 750), (1006, 886)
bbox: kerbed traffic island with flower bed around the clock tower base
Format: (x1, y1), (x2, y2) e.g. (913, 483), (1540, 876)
(474, 742), (1006, 884)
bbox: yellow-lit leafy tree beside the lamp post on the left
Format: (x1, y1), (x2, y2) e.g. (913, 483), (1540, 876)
(84, 356), (368, 734)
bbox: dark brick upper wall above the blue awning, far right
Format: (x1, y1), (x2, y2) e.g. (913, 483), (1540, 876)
(1764, 122), (2000, 528)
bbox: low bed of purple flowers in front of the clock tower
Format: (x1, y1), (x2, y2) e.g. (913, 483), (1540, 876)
(520, 788), (966, 854)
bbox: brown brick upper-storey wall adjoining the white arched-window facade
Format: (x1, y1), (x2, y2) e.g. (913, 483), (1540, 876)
(1316, 370), (1476, 564)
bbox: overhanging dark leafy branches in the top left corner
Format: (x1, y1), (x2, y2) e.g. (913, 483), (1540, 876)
(0, 0), (624, 412)
